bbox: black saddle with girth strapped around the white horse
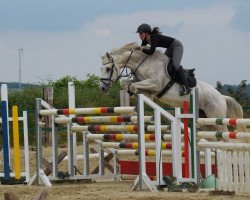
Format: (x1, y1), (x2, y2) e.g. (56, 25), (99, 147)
(156, 59), (196, 98)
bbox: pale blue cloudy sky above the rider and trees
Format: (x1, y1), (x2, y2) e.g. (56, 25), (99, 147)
(0, 0), (250, 86)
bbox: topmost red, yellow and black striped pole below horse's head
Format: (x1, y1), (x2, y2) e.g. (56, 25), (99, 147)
(40, 106), (136, 115)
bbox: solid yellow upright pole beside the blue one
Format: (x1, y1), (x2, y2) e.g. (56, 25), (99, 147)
(12, 106), (21, 179)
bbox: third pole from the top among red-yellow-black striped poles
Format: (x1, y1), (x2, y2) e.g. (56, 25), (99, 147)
(71, 125), (170, 132)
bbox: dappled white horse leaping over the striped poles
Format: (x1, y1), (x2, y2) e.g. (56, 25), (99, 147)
(100, 43), (246, 134)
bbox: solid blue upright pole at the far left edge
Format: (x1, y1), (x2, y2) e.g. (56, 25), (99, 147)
(1, 101), (10, 180)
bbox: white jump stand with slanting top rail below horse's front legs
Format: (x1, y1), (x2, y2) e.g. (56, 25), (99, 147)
(131, 94), (181, 192)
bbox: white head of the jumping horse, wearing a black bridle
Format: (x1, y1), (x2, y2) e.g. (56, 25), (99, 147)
(100, 52), (120, 92)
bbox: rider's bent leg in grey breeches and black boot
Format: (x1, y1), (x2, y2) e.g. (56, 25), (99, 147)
(171, 40), (191, 96)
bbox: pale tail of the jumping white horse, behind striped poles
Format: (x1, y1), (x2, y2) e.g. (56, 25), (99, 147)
(224, 95), (247, 132)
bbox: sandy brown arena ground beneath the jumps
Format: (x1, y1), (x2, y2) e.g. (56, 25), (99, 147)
(0, 147), (250, 200)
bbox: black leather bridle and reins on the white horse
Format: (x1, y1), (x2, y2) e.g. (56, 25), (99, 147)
(100, 51), (148, 86)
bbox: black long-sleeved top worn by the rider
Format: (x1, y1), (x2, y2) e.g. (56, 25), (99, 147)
(141, 34), (174, 55)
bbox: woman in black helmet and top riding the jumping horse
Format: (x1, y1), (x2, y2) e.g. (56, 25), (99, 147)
(136, 24), (191, 96)
